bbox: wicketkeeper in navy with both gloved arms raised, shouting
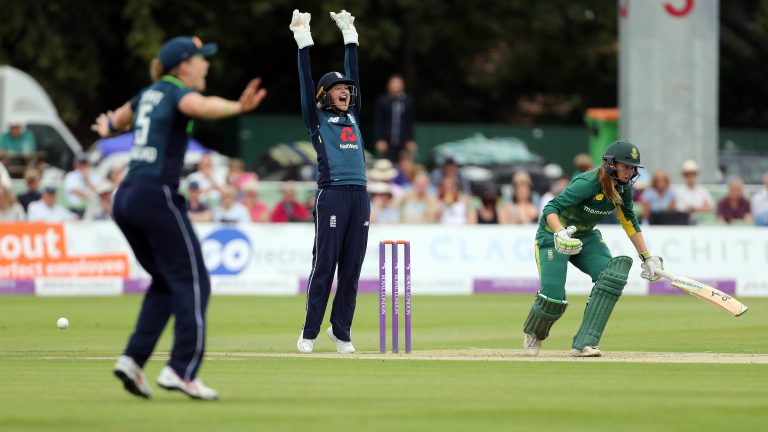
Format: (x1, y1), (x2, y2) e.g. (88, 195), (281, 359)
(289, 10), (371, 353)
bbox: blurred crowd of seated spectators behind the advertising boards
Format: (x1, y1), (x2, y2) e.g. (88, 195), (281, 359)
(0, 150), (768, 226)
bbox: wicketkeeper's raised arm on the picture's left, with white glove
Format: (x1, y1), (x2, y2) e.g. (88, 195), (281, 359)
(288, 9), (319, 129)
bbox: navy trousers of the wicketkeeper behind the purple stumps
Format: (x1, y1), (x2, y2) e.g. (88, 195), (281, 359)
(303, 186), (371, 341)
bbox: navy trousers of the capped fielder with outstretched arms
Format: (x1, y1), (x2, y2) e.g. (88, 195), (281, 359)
(113, 177), (211, 380)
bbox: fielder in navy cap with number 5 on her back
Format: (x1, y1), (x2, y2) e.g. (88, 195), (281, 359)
(91, 36), (266, 400)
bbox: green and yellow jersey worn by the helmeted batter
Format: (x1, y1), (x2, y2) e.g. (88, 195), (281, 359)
(537, 171), (640, 237)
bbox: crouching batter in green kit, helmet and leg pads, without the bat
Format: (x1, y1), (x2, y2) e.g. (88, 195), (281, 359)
(523, 141), (664, 357)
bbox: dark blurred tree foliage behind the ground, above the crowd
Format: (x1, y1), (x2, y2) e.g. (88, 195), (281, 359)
(0, 0), (768, 145)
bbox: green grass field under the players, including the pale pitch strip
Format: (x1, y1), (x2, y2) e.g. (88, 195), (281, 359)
(0, 295), (768, 432)
